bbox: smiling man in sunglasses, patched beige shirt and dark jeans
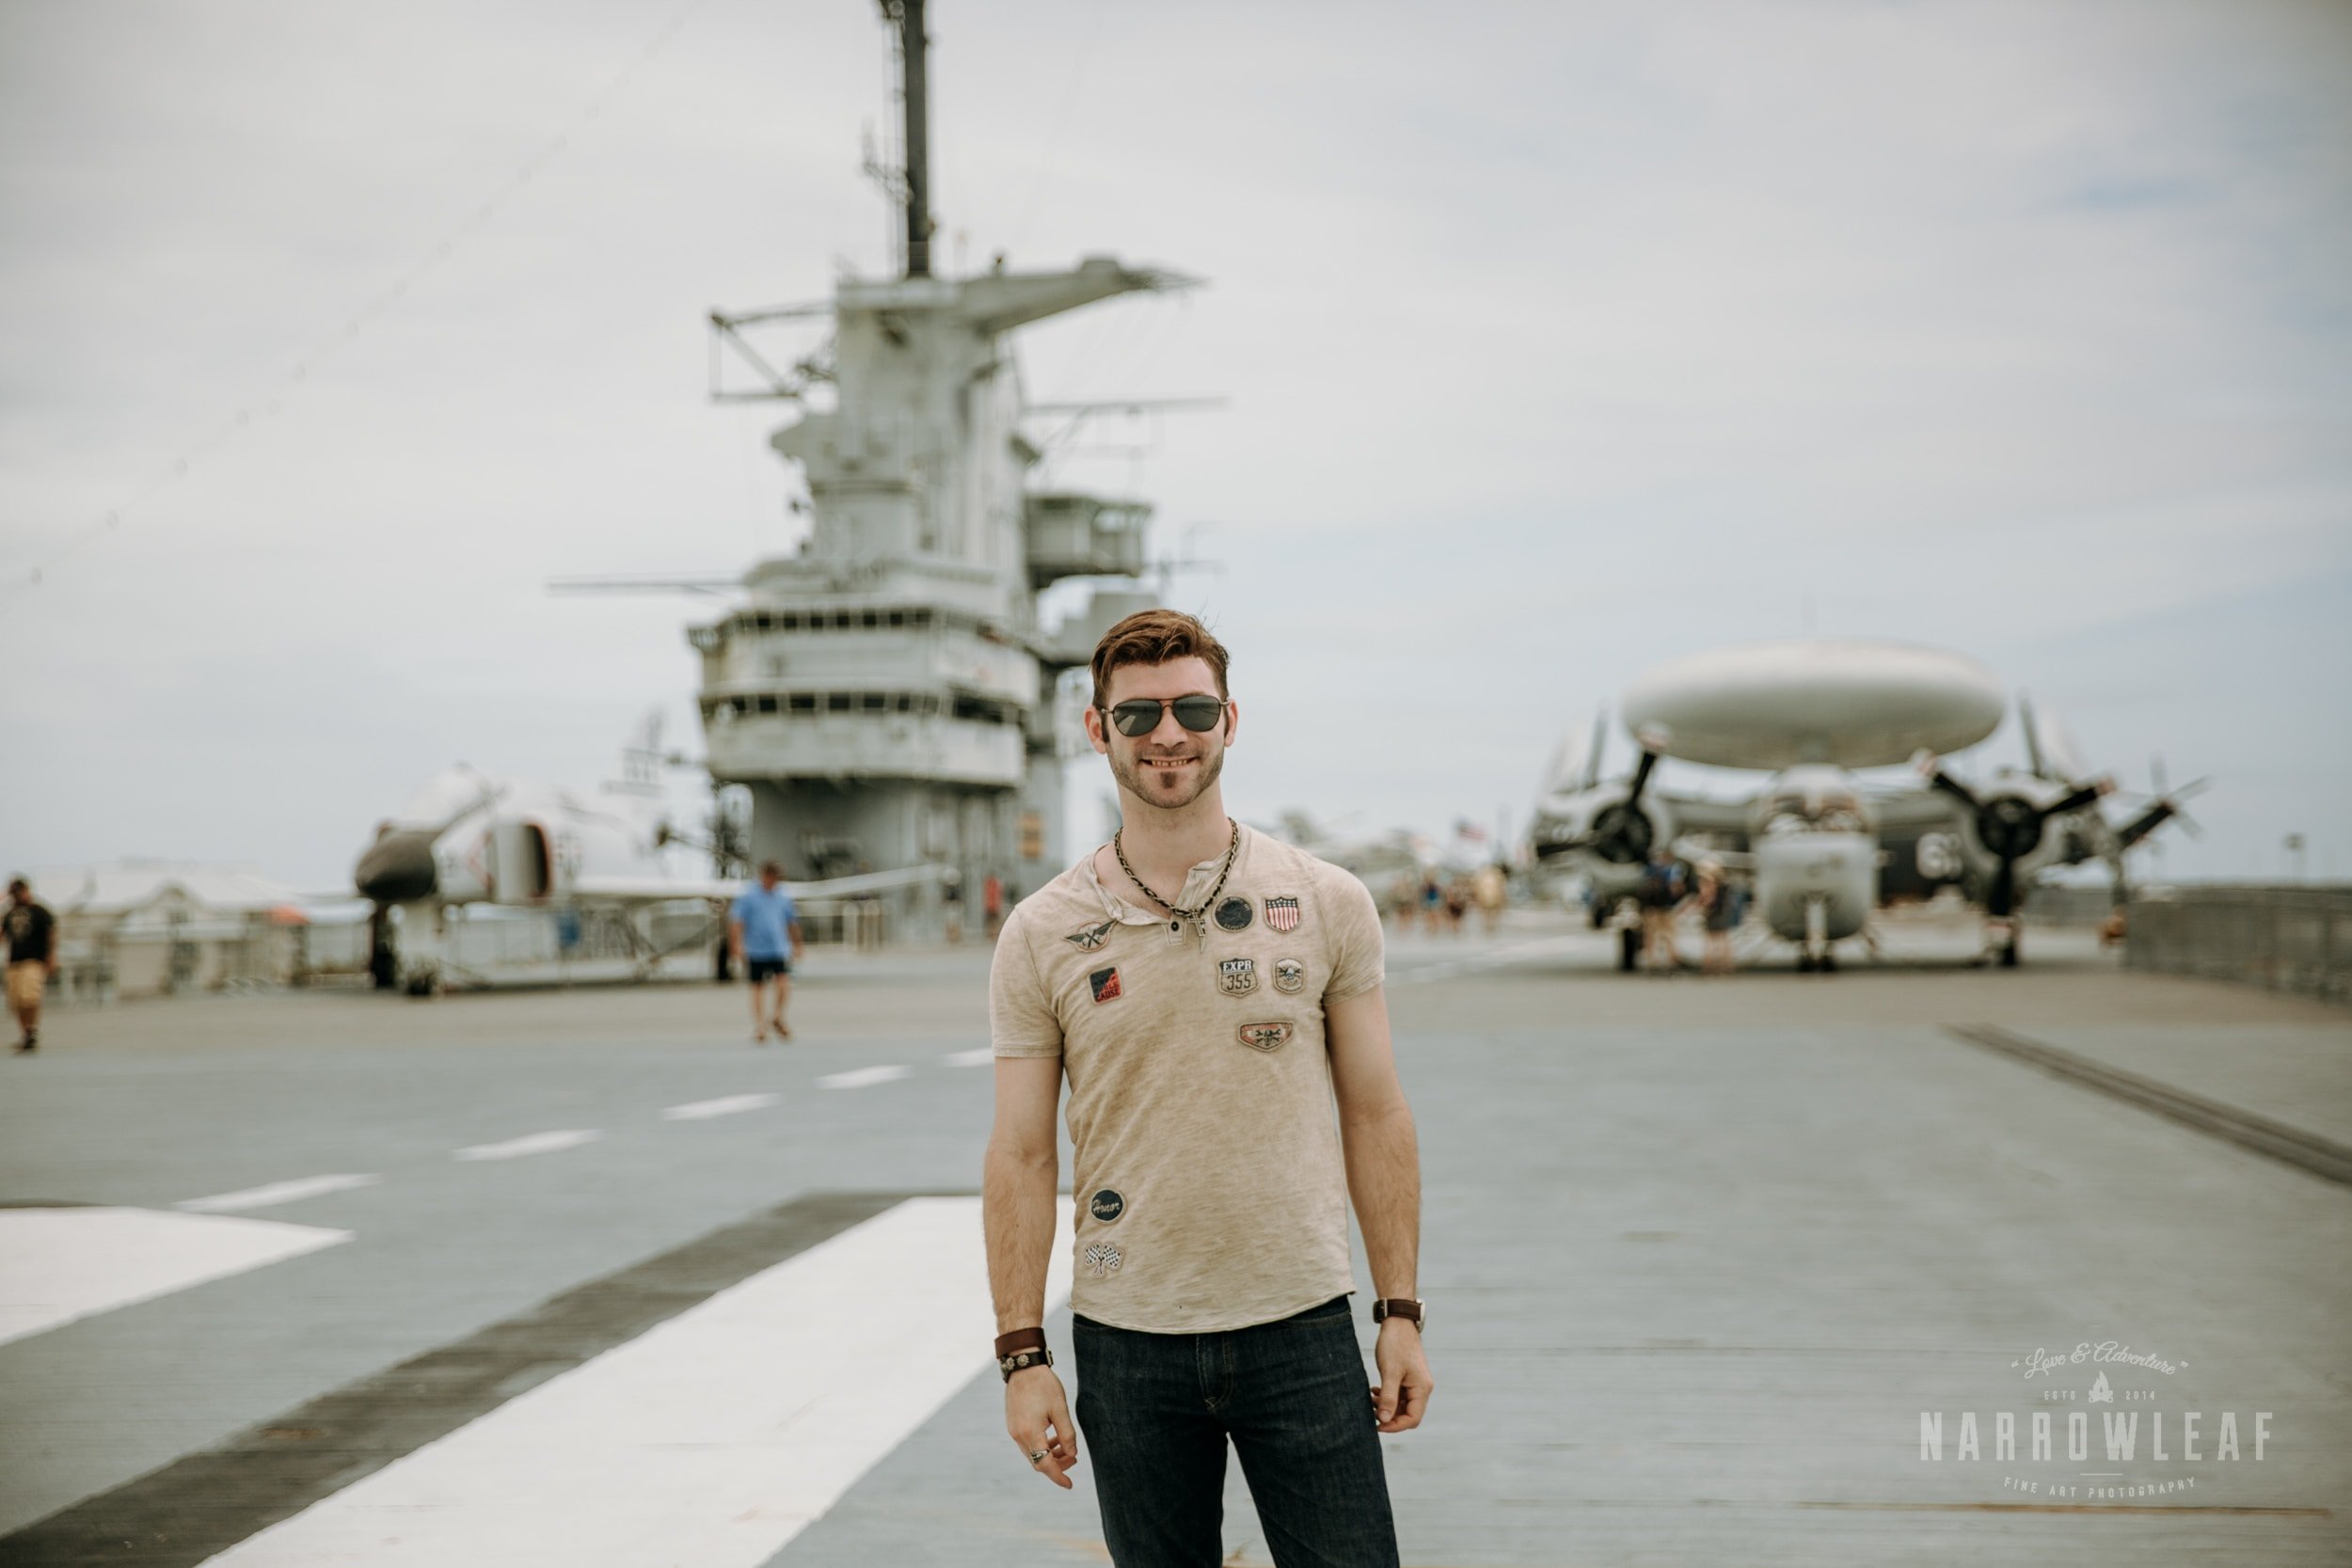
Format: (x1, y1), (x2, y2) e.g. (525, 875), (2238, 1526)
(983, 611), (1433, 1568)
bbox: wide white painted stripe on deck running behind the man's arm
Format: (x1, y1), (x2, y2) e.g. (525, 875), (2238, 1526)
(207, 1199), (1071, 1568)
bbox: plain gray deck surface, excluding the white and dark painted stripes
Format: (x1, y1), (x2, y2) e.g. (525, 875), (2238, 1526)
(0, 914), (2352, 1568)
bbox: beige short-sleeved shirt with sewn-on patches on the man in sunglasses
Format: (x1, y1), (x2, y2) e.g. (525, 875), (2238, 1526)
(988, 828), (1381, 1333)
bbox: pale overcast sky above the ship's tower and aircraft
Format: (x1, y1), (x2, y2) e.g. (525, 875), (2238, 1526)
(0, 0), (2352, 886)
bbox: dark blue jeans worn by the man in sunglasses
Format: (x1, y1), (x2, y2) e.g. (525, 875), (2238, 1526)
(1073, 1295), (1397, 1568)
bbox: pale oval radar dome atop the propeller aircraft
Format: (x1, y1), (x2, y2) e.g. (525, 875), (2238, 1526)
(1621, 640), (2007, 768)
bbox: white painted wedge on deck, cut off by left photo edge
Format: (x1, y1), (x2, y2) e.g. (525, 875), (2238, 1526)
(0, 1209), (351, 1345)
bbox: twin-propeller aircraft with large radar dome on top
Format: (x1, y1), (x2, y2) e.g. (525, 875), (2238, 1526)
(1529, 640), (2204, 969)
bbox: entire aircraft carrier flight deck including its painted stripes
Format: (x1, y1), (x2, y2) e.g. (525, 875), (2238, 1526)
(0, 912), (2352, 1568)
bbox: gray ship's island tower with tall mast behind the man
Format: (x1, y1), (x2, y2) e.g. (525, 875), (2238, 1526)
(690, 0), (1190, 898)
